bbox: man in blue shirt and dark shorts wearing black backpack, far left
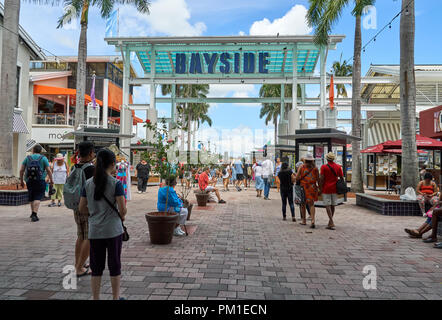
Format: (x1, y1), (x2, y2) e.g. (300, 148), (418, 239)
(20, 144), (54, 222)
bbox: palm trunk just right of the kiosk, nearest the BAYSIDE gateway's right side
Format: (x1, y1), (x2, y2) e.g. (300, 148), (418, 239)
(351, 16), (364, 193)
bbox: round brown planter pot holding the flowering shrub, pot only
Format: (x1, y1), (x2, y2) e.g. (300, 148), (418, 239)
(145, 212), (178, 244)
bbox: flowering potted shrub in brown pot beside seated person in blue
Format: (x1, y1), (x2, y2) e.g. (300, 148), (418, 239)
(142, 120), (178, 244)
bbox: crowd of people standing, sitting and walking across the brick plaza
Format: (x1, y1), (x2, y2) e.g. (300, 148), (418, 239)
(15, 142), (442, 299)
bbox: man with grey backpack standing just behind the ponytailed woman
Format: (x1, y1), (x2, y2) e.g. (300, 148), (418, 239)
(63, 141), (95, 277)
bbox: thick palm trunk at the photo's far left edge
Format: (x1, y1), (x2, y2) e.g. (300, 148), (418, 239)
(0, 0), (20, 177)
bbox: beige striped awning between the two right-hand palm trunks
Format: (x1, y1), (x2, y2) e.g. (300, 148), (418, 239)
(368, 120), (401, 146)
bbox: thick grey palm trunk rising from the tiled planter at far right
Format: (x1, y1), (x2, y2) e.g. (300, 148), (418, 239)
(400, 0), (419, 193)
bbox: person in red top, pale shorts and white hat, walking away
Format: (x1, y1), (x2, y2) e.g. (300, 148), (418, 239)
(319, 152), (344, 230)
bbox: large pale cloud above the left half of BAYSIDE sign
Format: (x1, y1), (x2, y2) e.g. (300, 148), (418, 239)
(120, 0), (207, 36)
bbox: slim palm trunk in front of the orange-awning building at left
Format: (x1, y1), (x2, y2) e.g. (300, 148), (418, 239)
(75, 0), (89, 130)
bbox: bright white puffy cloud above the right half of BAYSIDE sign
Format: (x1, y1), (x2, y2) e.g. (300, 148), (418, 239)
(250, 4), (312, 35)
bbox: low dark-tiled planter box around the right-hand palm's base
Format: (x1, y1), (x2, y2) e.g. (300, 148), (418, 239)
(356, 193), (422, 217)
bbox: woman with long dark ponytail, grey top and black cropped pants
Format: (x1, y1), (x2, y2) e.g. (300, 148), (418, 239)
(79, 149), (127, 300)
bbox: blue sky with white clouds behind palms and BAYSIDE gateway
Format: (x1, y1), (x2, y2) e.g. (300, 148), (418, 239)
(13, 0), (442, 154)
